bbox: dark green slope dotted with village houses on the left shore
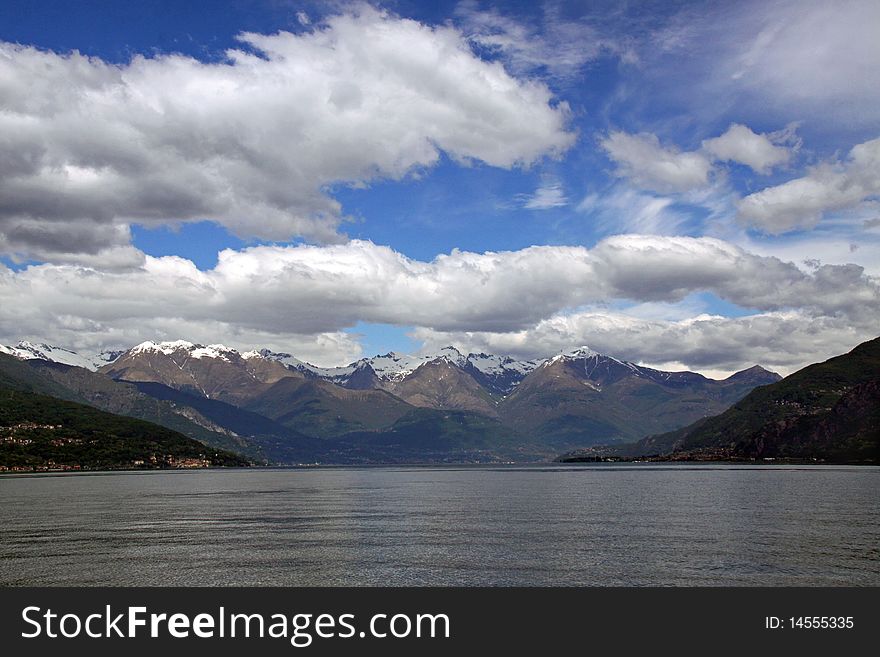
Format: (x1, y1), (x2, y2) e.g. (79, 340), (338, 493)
(0, 385), (247, 469)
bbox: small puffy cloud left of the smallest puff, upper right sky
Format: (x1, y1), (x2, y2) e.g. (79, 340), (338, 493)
(600, 131), (712, 192)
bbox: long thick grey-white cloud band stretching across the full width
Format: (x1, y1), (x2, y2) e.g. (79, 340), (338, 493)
(0, 235), (880, 372)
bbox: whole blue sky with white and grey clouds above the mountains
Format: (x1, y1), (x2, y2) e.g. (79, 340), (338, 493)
(0, 0), (880, 376)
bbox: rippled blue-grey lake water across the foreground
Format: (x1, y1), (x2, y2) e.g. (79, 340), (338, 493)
(0, 464), (880, 586)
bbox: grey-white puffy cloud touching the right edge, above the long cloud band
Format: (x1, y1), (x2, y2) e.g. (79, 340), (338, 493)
(738, 138), (880, 235)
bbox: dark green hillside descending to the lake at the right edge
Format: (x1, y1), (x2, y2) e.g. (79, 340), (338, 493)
(628, 338), (880, 461)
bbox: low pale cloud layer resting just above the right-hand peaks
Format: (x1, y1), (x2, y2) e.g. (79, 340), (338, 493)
(412, 310), (878, 377)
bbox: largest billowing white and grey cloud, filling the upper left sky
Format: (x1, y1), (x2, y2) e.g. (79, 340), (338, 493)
(0, 5), (574, 254)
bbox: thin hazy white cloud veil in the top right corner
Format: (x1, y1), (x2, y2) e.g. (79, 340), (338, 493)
(640, 0), (880, 125)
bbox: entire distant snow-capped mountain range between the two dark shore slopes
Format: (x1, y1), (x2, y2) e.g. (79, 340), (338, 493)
(0, 340), (780, 463)
